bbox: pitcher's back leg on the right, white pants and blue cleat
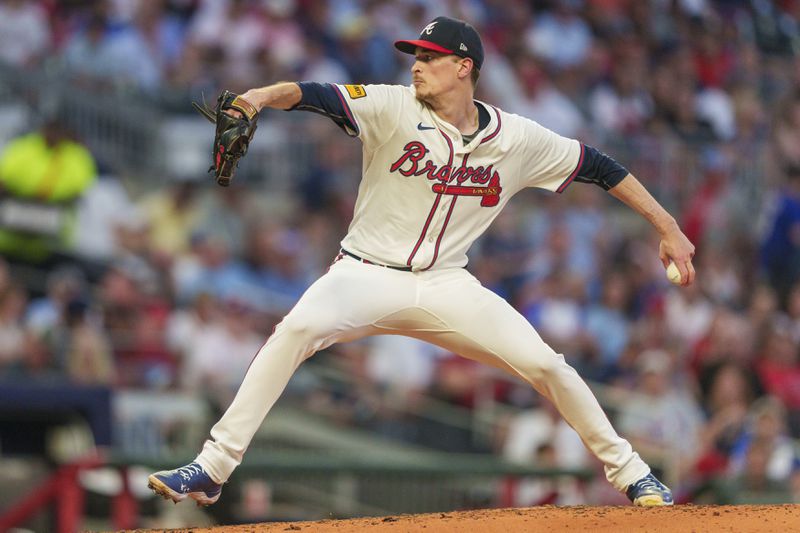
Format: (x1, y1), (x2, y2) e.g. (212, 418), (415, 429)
(412, 269), (672, 505)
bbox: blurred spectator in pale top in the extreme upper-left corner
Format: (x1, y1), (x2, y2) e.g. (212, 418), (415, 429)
(0, 0), (51, 67)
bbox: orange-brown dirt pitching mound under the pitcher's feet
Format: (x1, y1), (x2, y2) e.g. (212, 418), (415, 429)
(152, 505), (800, 533)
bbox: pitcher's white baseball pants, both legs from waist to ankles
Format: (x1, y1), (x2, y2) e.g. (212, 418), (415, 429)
(196, 256), (650, 491)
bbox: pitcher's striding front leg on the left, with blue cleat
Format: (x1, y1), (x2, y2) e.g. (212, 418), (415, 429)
(149, 257), (416, 505)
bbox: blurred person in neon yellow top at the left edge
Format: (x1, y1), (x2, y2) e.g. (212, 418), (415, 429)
(0, 121), (97, 262)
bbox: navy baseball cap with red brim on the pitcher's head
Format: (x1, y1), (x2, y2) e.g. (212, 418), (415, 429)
(394, 17), (483, 70)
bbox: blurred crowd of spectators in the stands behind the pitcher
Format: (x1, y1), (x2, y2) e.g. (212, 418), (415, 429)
(0, 0), (800, 505)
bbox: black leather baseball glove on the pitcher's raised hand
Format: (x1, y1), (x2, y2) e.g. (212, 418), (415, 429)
(192, 91), (258, 187)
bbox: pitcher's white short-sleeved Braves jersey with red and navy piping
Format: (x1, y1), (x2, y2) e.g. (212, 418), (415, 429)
(336, 85), (582, 270)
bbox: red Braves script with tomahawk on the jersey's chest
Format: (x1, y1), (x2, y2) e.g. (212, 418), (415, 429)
(389, 141), (503, 207)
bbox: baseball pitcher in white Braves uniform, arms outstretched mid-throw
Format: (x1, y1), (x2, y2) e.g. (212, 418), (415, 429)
(149, 17), (695, 506)
